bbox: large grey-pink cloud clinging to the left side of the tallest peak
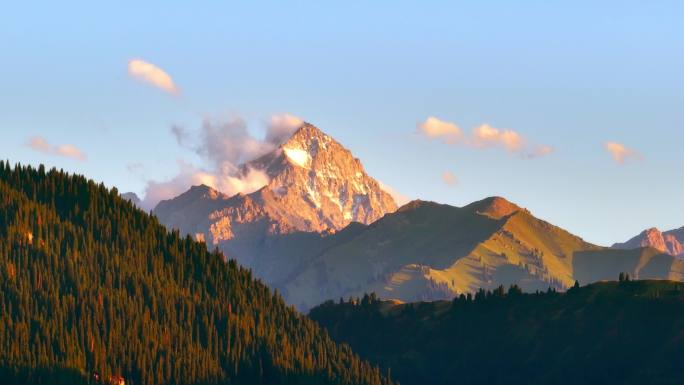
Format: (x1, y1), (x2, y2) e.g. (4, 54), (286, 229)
(143, 114), (303, 209)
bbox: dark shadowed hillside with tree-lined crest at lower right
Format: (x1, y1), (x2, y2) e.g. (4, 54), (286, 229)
(310, 281), (684, 385)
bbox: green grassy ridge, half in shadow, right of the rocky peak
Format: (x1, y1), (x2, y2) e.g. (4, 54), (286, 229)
(279, 197), (684, 309)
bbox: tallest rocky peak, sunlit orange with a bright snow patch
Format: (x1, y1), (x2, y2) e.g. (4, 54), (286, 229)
(154, 124), (397, 264)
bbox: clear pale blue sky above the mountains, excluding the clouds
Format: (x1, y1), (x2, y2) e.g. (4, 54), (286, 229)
(0, 1), (684, 244)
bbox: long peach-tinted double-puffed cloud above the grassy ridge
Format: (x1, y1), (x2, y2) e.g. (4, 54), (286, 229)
(418, 116), (554, 158)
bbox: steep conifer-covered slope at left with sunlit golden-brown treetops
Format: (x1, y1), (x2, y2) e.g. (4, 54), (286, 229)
(0, 162), (391, 385)
